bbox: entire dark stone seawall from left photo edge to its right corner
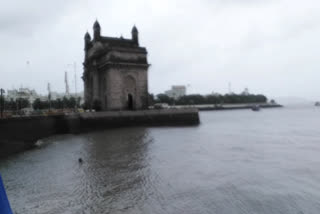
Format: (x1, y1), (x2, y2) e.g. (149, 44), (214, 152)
(0, 109), (200, 158)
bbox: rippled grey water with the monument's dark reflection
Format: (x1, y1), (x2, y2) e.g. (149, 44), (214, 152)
(0, 107), (320, 214)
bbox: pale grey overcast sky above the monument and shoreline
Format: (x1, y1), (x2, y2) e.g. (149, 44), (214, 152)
(0, 0), (320, 99)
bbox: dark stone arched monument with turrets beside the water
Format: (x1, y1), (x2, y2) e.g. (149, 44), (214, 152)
(82, 21), (149, 111)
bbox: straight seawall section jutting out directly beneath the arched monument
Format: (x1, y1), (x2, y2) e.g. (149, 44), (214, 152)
(67, 109), (200, 133)
